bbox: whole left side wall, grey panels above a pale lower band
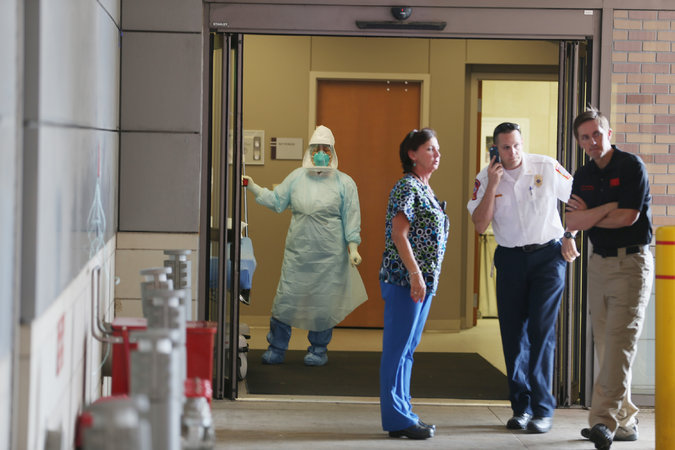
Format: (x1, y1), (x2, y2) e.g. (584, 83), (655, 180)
(17, 0), (120, 449)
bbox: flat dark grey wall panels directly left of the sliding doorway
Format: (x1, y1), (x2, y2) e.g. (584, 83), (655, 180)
(119, 0), (203, 233)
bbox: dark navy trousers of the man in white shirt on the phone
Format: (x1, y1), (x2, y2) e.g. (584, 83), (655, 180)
(494, 241), (567, 417)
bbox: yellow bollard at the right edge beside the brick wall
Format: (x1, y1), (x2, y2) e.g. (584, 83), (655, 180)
(655, 227), (675, 450)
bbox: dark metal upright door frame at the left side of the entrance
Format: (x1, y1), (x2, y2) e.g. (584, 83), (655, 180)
(199, 32), (243, 400)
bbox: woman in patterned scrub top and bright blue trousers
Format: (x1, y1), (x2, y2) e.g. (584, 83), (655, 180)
(380, 128), (449, 439)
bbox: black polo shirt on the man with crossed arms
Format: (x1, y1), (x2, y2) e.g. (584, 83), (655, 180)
(572, 146), (652, 249)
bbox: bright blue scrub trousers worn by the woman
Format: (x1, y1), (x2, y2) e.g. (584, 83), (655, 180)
(380, 282), (433, 431)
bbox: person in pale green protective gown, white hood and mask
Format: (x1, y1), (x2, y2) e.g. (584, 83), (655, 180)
(244, 125), (368, 366)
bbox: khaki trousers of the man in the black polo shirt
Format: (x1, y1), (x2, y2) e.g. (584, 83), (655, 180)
(588, 247), (654, 433)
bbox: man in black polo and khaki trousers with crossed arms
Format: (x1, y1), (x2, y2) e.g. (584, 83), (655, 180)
(566, 108), (654, 449)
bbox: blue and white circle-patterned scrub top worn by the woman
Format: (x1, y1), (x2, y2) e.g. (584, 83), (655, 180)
(380, 174), (450, 294)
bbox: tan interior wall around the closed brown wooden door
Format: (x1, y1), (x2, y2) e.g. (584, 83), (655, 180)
(242, 36), (558, 330)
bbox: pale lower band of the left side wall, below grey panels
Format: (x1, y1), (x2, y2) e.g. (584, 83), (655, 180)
(15, 238), (116, 449)
